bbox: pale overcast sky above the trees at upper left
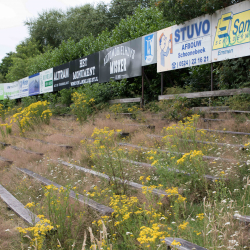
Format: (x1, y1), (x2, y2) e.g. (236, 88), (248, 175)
(0, 0), (111, 63)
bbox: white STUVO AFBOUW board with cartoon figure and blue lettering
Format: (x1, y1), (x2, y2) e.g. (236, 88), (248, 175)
(157, 15), (212, 72)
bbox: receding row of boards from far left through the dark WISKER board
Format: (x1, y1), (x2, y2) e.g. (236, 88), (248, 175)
(0, 37), (142, 100)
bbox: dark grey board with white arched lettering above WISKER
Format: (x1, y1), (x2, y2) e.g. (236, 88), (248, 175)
(99, 37), (142, 82)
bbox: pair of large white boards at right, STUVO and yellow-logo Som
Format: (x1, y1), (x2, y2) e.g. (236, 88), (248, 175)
(156, 1), (250, 72)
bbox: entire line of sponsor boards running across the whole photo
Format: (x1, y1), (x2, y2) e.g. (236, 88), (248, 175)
(0, 1), (250, 99)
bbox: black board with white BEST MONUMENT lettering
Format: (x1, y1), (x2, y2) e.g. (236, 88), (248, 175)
(69, 52), (99, 87)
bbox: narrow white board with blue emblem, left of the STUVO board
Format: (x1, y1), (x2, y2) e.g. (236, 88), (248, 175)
(142, 32), (157, 66)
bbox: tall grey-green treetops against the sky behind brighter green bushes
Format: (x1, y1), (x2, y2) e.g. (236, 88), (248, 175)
(25, 0), (155, 52)
